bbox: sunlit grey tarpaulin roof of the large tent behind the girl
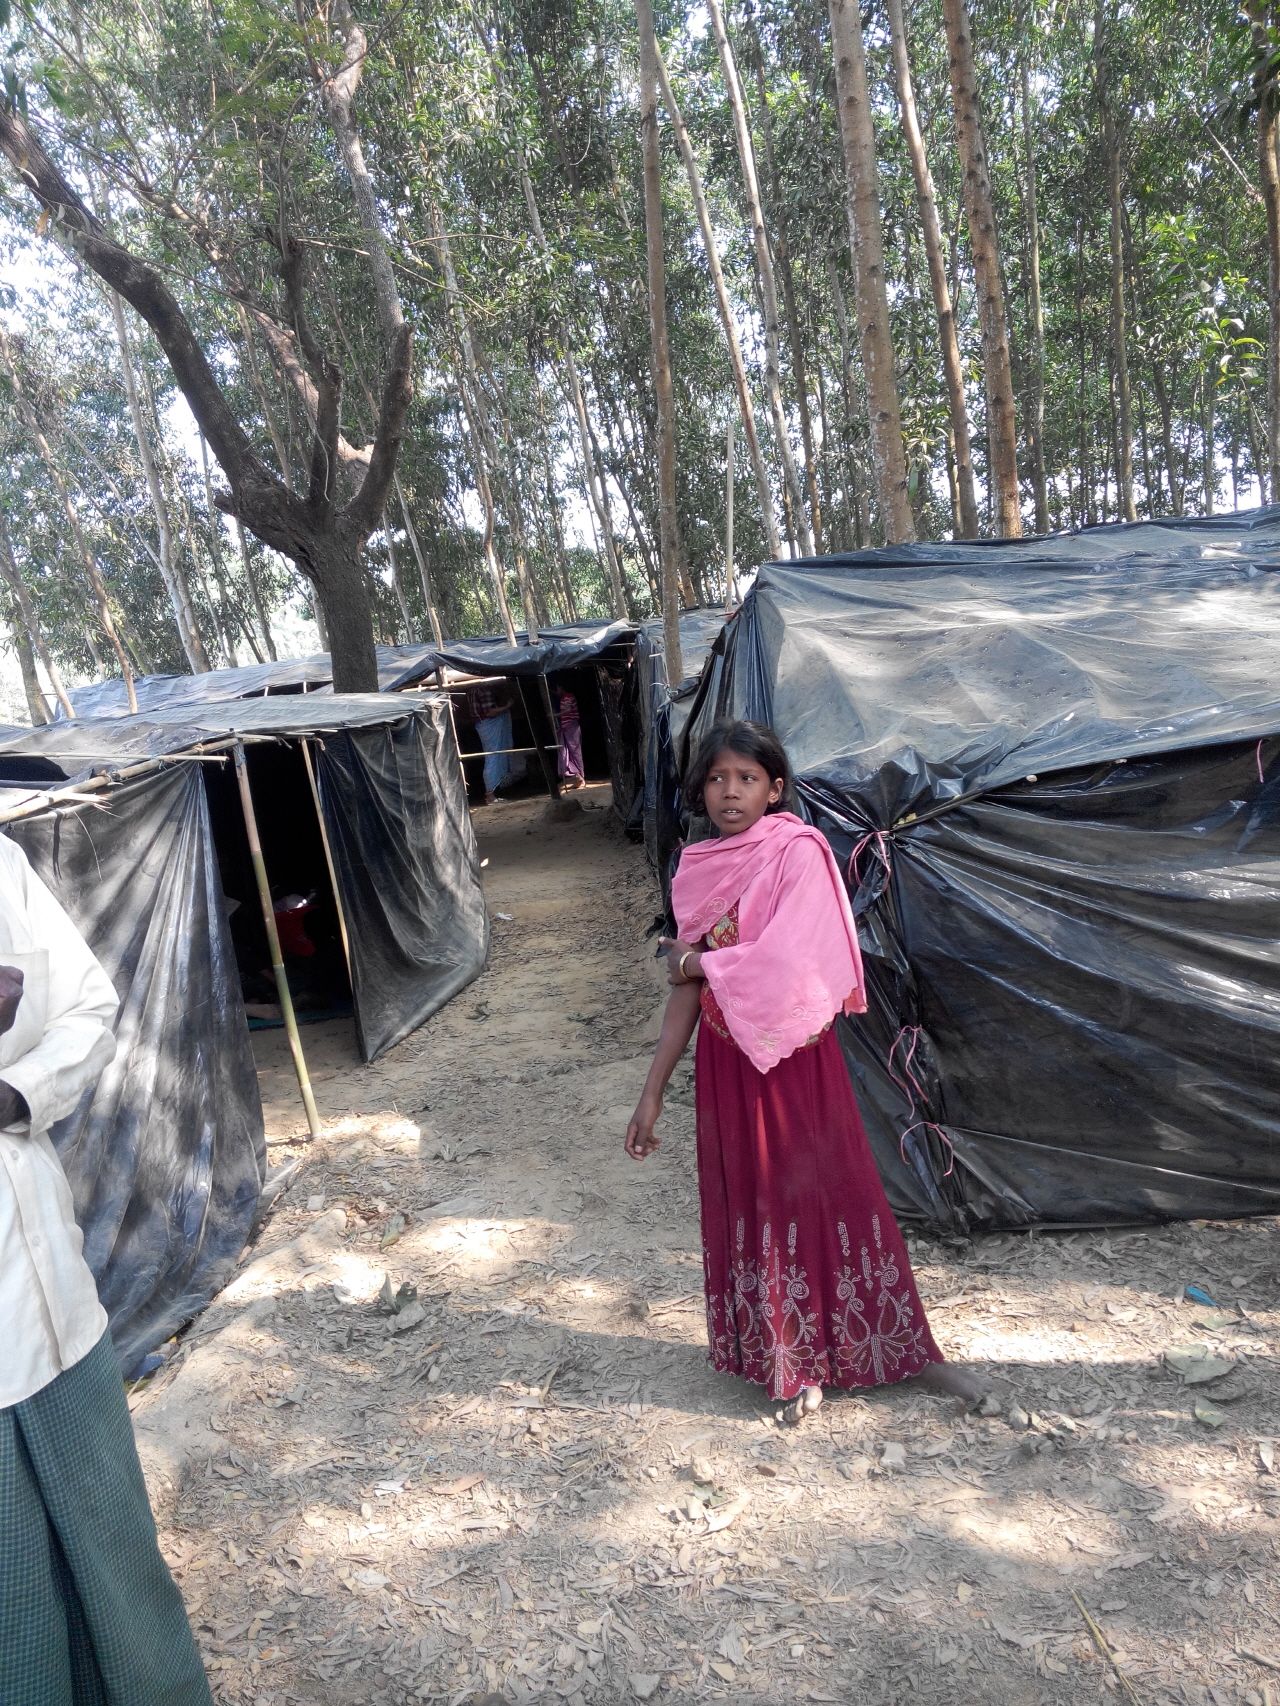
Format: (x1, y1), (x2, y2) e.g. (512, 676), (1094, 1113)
(732, 505), (1280, 822)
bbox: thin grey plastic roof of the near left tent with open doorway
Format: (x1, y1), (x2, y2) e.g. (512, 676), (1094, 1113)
(0, 689), (423, 780)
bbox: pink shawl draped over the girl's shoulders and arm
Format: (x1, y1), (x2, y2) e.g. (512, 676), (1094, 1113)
(671, 812), (867, 1071)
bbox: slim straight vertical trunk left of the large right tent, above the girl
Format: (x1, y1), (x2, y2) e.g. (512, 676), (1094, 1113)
(635, 0), (686, 688)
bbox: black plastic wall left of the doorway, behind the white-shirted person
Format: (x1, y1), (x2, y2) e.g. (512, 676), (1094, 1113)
(0, 764), (266, 1372)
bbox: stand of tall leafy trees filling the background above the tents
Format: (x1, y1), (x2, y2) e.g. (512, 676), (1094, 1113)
(0, 0), (1280, 699)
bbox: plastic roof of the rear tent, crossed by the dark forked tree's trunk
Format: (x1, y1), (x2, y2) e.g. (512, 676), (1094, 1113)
(56, 619), (637, 722)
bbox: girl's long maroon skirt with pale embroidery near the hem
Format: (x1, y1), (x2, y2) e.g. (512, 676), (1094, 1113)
(696, 1017), (944, 1399)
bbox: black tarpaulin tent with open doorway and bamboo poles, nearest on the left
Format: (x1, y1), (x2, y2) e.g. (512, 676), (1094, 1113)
(0, 694), (488, 1368)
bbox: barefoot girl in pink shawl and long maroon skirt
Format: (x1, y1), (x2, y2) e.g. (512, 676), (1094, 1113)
(626, 720), (983, 1421)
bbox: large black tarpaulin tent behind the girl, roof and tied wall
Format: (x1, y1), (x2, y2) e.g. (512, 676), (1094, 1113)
(684, 507), (1280, 1232)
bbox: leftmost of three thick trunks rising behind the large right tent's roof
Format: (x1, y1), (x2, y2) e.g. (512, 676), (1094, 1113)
(828, 0), (915, 544)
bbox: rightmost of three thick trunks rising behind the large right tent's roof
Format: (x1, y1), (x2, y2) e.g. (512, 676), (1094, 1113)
(942, 0), (1022, 539)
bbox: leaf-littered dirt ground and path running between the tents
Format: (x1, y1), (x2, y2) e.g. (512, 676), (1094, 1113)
(133, 790), (1280, 1706)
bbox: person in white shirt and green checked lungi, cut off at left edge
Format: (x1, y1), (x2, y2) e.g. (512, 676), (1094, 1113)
(0, 836), (210, 1706)
